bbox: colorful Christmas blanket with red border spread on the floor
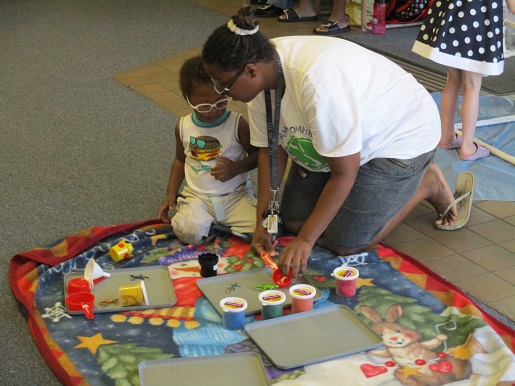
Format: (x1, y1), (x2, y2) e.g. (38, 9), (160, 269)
(13, 224), (515, 385)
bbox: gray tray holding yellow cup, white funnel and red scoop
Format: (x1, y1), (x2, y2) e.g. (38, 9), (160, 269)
(64, 266), (177, 315)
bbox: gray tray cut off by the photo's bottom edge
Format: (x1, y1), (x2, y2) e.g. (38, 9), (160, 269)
(138, 352), (270, 386)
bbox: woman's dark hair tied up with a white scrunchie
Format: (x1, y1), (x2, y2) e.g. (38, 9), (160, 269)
(202, 7), (276, 71)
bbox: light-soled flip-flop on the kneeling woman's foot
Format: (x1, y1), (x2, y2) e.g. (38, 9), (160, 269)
(435, 172), (475, 231)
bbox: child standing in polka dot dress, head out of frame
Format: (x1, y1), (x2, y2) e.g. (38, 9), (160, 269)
(413, 0), (515, 161)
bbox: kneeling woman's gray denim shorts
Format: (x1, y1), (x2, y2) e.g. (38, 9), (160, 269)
(281, 150), (436, 250)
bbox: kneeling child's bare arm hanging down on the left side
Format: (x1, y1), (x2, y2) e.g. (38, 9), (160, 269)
(157, 122), (186, 223)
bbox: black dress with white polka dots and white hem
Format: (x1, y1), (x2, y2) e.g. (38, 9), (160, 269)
(413, 0), (504, 75)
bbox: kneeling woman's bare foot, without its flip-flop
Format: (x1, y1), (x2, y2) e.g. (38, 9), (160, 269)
(422, 163), (458, 226)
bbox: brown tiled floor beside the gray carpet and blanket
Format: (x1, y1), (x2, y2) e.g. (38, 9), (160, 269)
(115, 0), (515, 320)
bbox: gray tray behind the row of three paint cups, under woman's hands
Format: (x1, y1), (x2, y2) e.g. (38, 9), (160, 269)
(197, 267), (322, 315)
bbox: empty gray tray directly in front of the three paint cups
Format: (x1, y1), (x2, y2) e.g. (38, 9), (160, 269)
(245, 305), (383, 369)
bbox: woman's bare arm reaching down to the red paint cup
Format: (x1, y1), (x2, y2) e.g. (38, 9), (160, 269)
(279, 153), (360, 279)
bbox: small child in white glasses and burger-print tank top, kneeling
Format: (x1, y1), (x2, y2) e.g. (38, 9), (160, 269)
(158, 56), (258, 243)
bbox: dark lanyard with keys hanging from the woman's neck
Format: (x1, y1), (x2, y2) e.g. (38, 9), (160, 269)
(265, 59), (284, 229)
